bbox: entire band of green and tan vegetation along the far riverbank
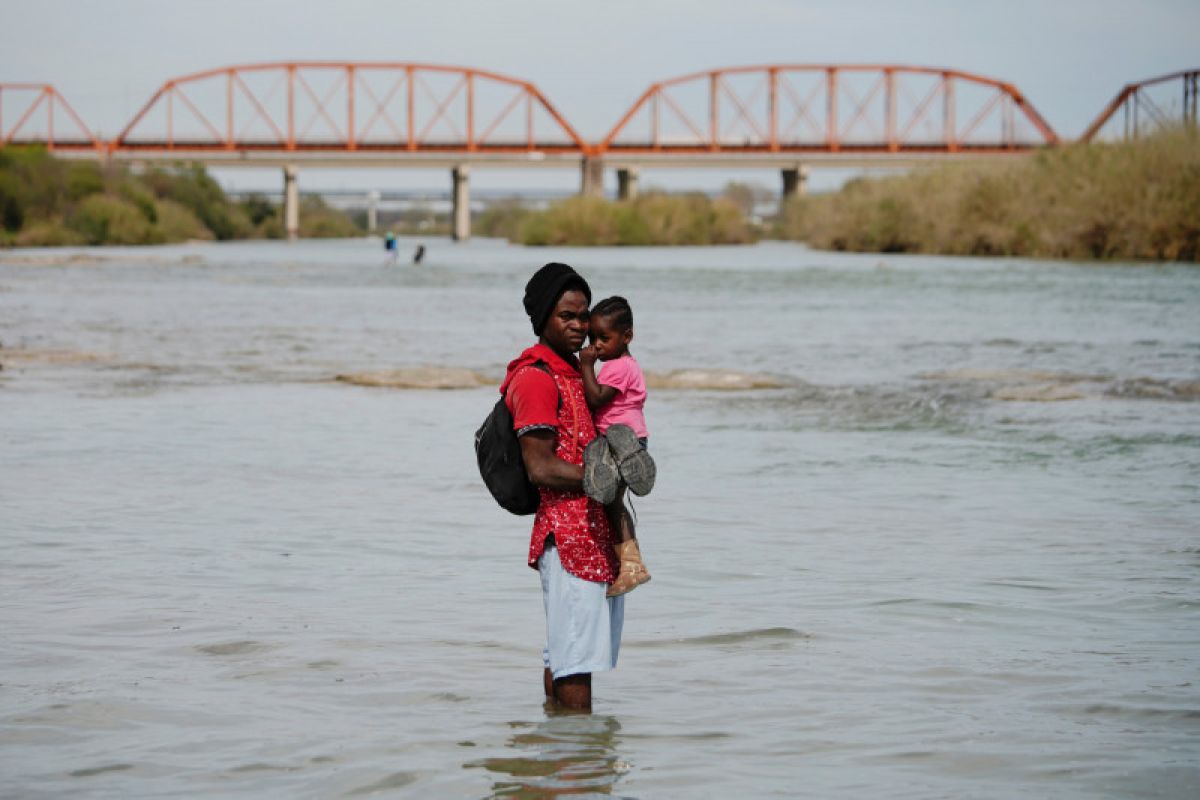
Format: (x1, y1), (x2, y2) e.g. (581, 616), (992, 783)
(0, 130), (1200, 261)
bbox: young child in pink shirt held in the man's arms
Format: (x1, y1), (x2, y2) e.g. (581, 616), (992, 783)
(580, 296), (654, 597)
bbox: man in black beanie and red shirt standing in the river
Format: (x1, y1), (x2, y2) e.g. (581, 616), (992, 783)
(500, 264), (629, 710)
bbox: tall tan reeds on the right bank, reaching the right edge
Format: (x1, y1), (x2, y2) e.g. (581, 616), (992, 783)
(776, 130), (1200, 261)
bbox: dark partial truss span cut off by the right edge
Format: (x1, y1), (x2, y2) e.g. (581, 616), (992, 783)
(1080, 68), (1200, 142)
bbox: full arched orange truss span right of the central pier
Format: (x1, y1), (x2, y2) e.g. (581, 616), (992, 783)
(599, 65), (1058, 154)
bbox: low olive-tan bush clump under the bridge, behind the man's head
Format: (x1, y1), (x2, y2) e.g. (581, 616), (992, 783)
(476, 192), (757, 246)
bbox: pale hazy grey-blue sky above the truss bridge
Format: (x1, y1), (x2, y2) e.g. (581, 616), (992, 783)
(0, 0), (1200, 186)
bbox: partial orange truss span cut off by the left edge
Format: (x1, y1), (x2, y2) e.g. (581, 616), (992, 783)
(0, 83), (103, 150)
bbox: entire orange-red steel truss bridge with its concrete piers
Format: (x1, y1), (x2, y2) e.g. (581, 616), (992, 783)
(0, 61), (1198, 235)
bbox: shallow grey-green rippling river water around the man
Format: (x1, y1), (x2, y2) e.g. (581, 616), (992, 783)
(0, 240), (1200, 798)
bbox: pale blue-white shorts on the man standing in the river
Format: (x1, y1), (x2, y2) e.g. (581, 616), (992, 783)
(538, 542), (625, 678)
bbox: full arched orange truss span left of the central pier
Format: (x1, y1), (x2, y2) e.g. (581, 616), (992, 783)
(113, 61), (587, 152)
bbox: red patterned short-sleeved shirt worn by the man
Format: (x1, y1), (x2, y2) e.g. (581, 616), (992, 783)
(500, 344), (619, 583)
